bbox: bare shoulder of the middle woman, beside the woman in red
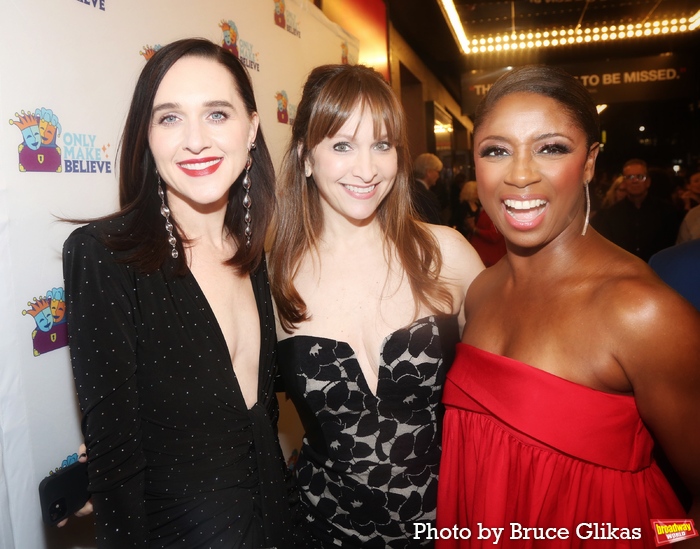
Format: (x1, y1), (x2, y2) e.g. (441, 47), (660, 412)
(423, 224), (484, 292)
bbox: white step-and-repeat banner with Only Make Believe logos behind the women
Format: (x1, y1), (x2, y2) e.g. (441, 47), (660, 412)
(0, 0), (359, 549)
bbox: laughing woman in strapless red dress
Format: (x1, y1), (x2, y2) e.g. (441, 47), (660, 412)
(433, 66), (700, 549)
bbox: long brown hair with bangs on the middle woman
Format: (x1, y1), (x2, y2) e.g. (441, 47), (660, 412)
(270, 65), (451, 332)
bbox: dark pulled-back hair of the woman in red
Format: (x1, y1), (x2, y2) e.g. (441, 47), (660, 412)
(474, 65), (600, 147)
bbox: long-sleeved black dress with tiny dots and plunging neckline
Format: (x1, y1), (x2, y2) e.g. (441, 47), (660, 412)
(64, 219), (289, 549)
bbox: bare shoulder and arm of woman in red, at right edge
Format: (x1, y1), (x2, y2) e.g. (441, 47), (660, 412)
(596, 255), (700, 494)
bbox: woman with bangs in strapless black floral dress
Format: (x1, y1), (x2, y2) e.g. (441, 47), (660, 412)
(270, 65), (483, 549)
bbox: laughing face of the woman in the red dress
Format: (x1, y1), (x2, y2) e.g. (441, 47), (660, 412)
(474, 92), (598, 247)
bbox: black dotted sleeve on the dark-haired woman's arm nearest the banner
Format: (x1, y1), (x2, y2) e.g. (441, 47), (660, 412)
(63, 227), (148, 549)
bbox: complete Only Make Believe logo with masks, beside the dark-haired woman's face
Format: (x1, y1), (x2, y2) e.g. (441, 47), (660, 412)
(10, 107), (112, 173)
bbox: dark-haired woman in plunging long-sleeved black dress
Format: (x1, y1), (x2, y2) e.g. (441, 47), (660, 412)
(64, 39), (291, 549)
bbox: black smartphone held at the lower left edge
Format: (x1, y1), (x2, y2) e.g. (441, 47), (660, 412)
(39, 461), (90, 526)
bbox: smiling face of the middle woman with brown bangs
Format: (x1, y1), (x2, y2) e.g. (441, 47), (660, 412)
(306, 107), (398, 225)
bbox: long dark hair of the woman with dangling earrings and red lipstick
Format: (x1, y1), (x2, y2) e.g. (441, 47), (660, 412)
(89, 38), (275, 274)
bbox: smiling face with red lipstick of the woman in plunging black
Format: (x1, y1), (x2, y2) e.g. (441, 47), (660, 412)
(148, 56), (258, 212)
